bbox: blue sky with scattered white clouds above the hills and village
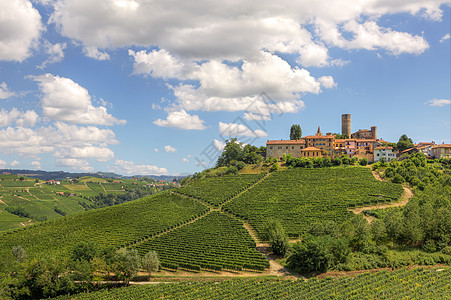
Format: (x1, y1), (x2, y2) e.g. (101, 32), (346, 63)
(0, 0), (451, 175)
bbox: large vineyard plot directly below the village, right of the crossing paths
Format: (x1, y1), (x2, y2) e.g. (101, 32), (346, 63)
(224, 167), (403, 237)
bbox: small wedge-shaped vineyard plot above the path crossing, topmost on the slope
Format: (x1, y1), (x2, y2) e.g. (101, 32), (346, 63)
(178, 174), (265, 206)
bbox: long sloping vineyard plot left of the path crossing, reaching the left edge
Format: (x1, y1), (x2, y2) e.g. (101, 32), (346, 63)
(0, 193), (208, 256)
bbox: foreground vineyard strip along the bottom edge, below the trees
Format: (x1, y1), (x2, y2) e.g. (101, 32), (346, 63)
(58, 268), (451, 300)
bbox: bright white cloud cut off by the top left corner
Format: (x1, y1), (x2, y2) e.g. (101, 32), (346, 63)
(0, 0), (43, 62)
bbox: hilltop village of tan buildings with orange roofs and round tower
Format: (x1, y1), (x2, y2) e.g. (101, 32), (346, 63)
(266, 114), (451, 162)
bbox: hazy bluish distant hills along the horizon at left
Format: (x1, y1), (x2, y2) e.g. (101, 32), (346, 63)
(0, 169), (186, 182)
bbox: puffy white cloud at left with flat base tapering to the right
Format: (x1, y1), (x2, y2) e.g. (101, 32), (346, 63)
(31, 73), (126, 125)
